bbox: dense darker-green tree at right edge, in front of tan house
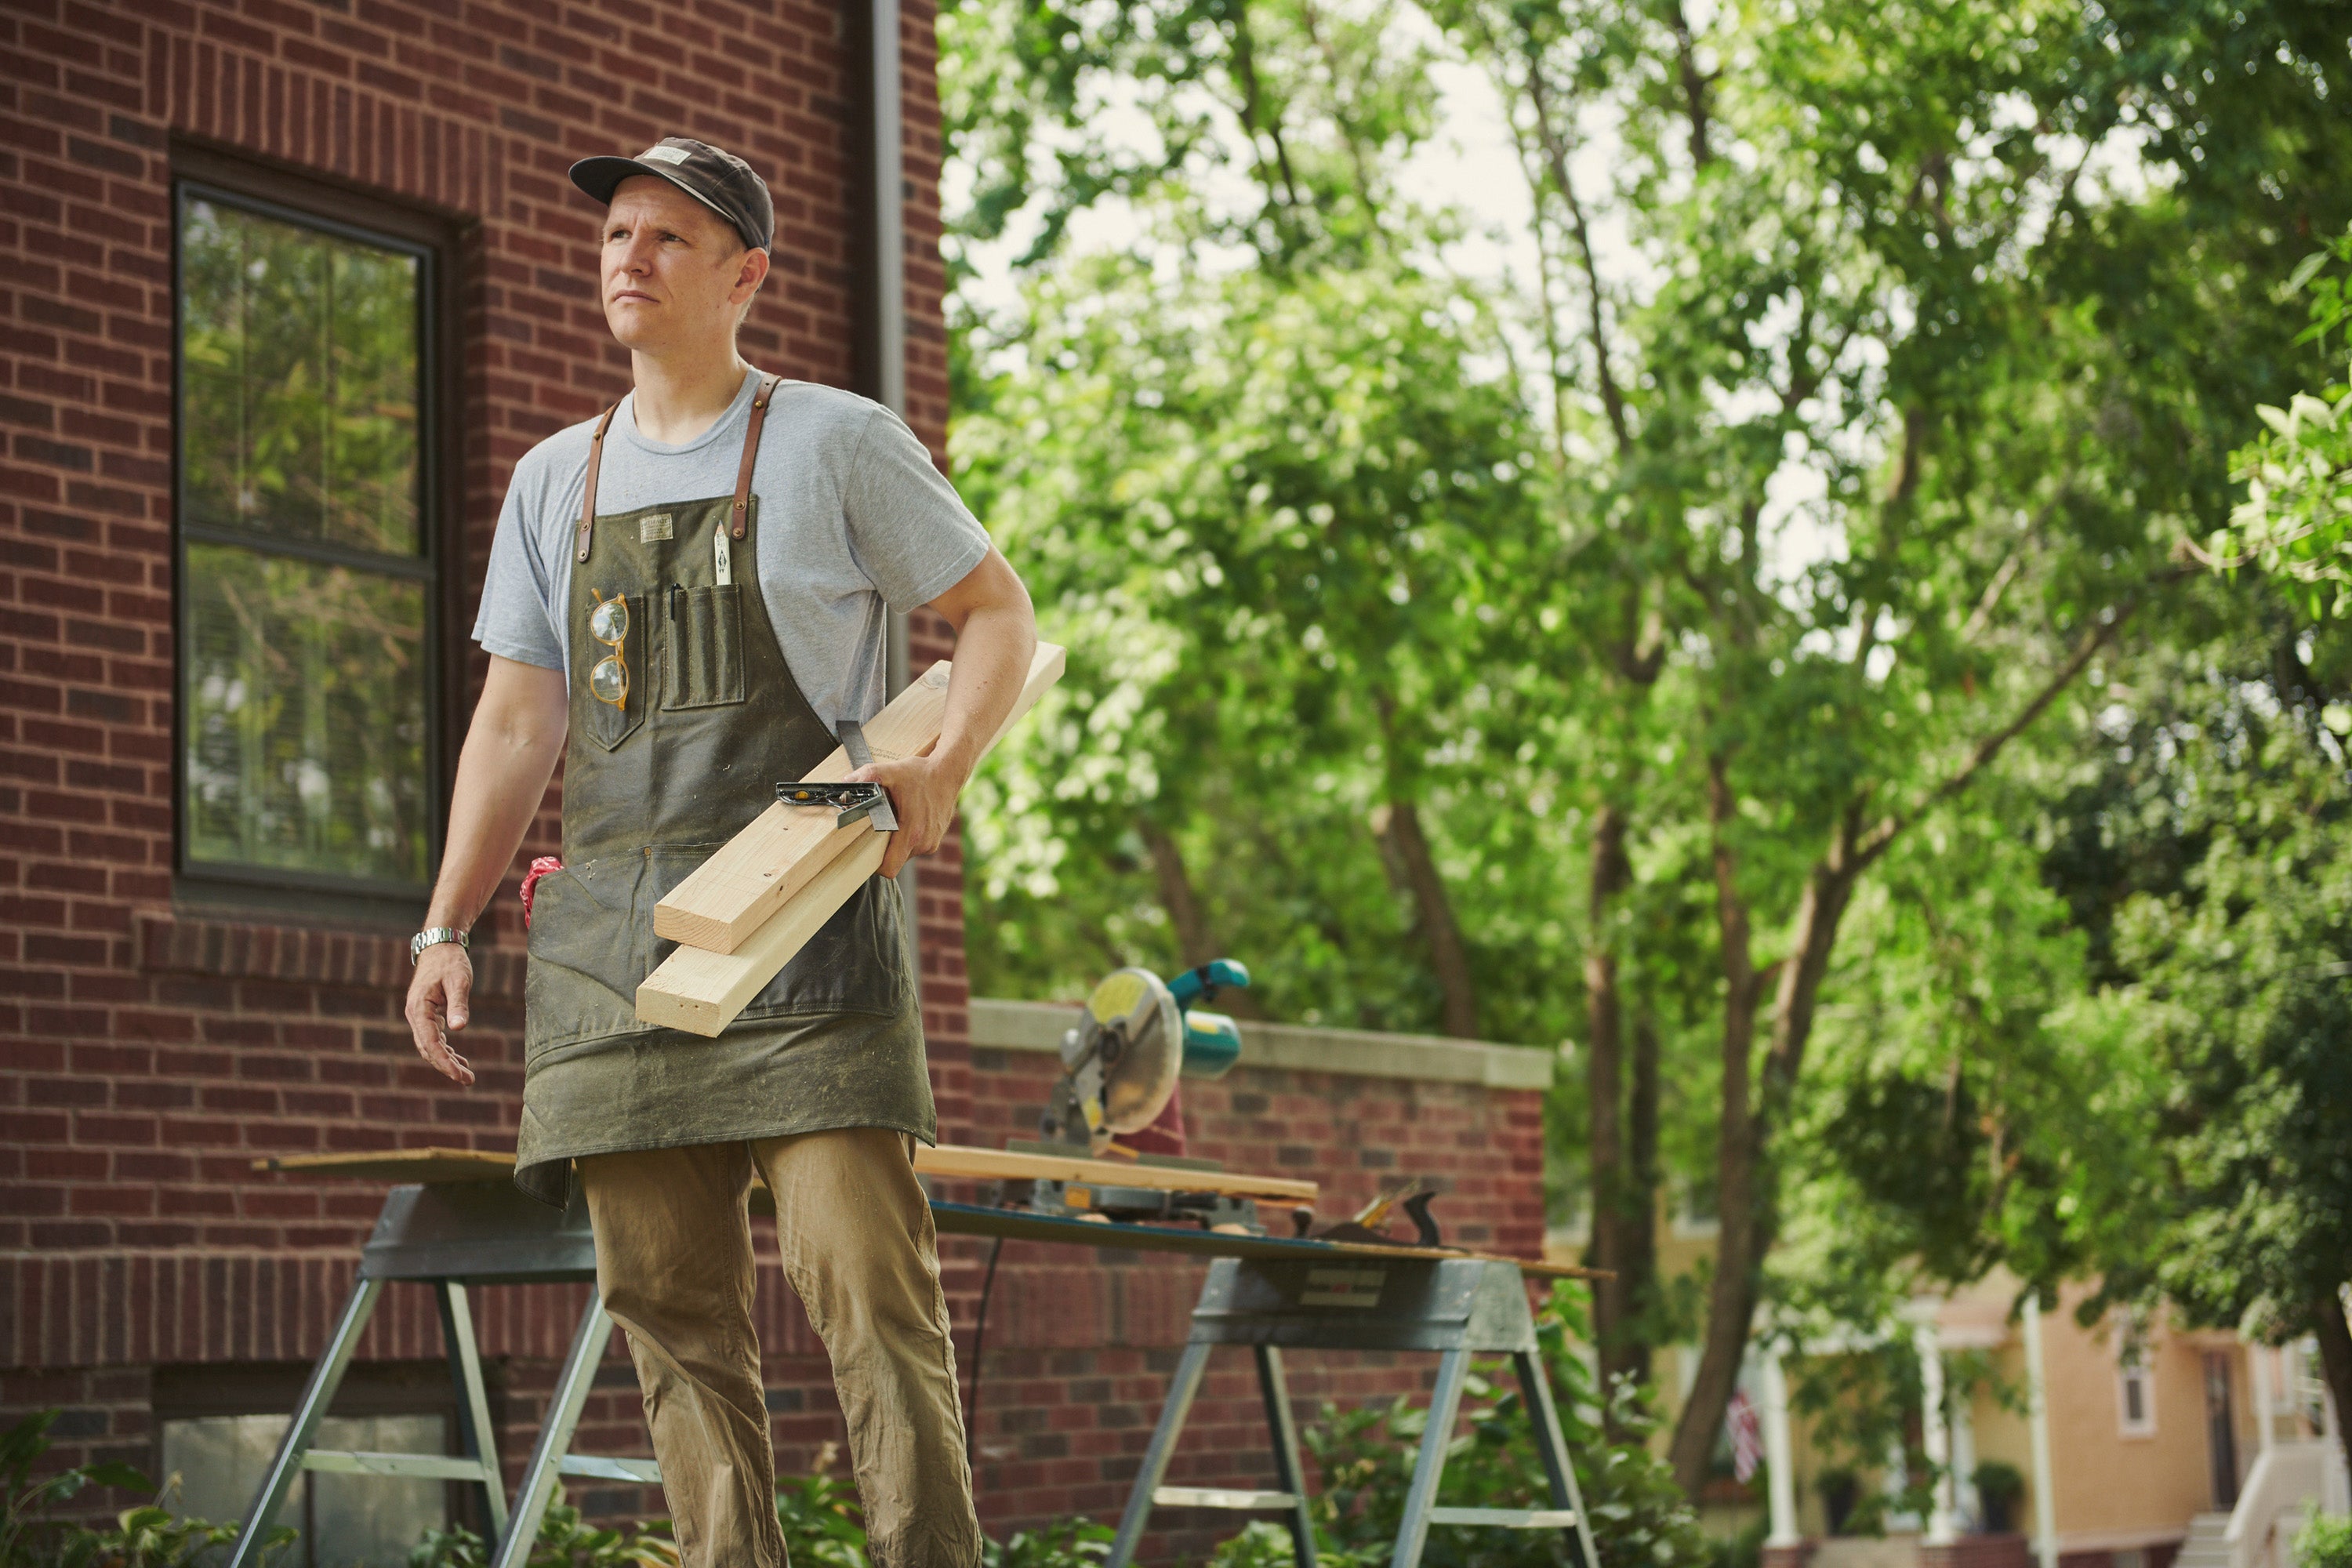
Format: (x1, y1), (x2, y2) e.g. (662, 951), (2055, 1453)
(2049, 606), (2352, 1486)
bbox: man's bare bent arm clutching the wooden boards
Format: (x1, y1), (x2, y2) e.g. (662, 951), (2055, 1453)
(851, 546), (1037, 877)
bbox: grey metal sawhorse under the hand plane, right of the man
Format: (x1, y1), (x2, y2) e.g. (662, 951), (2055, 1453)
(1105, 1258), (1599, 1568)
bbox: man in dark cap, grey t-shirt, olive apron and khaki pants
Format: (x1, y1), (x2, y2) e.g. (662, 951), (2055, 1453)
(407, 136), (1037, 1568)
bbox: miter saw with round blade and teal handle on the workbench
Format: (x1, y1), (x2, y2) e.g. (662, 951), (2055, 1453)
(1009, 959), (1263, 1232)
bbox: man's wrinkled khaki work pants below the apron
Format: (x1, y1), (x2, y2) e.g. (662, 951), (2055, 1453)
(579, 1126), (981, 1568)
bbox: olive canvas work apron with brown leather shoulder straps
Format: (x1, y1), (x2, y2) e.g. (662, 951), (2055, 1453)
(515, 376), (938, 1203)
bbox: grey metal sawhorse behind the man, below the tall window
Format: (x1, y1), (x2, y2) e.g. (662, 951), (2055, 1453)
(228, 1175), (661, 1568)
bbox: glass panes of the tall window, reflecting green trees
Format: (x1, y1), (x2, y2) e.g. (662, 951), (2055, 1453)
(179, 188), (433, 888)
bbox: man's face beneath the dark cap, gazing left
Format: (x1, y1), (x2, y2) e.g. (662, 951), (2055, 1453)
(602, 174), (767, 353)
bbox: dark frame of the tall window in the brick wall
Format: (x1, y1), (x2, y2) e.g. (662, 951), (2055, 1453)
(172, 141), (466, 928)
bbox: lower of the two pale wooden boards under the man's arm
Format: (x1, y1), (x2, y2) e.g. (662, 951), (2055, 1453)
(637, 642), (1065, 1039)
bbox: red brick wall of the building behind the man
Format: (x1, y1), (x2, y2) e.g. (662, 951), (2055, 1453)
(0, 0), (1541, 1544)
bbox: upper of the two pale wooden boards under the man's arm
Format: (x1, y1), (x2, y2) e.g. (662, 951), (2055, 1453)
(654, 659), (953, 952)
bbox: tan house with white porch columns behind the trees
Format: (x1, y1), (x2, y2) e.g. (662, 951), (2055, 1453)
(1550, 1201), (2352, 1568)
